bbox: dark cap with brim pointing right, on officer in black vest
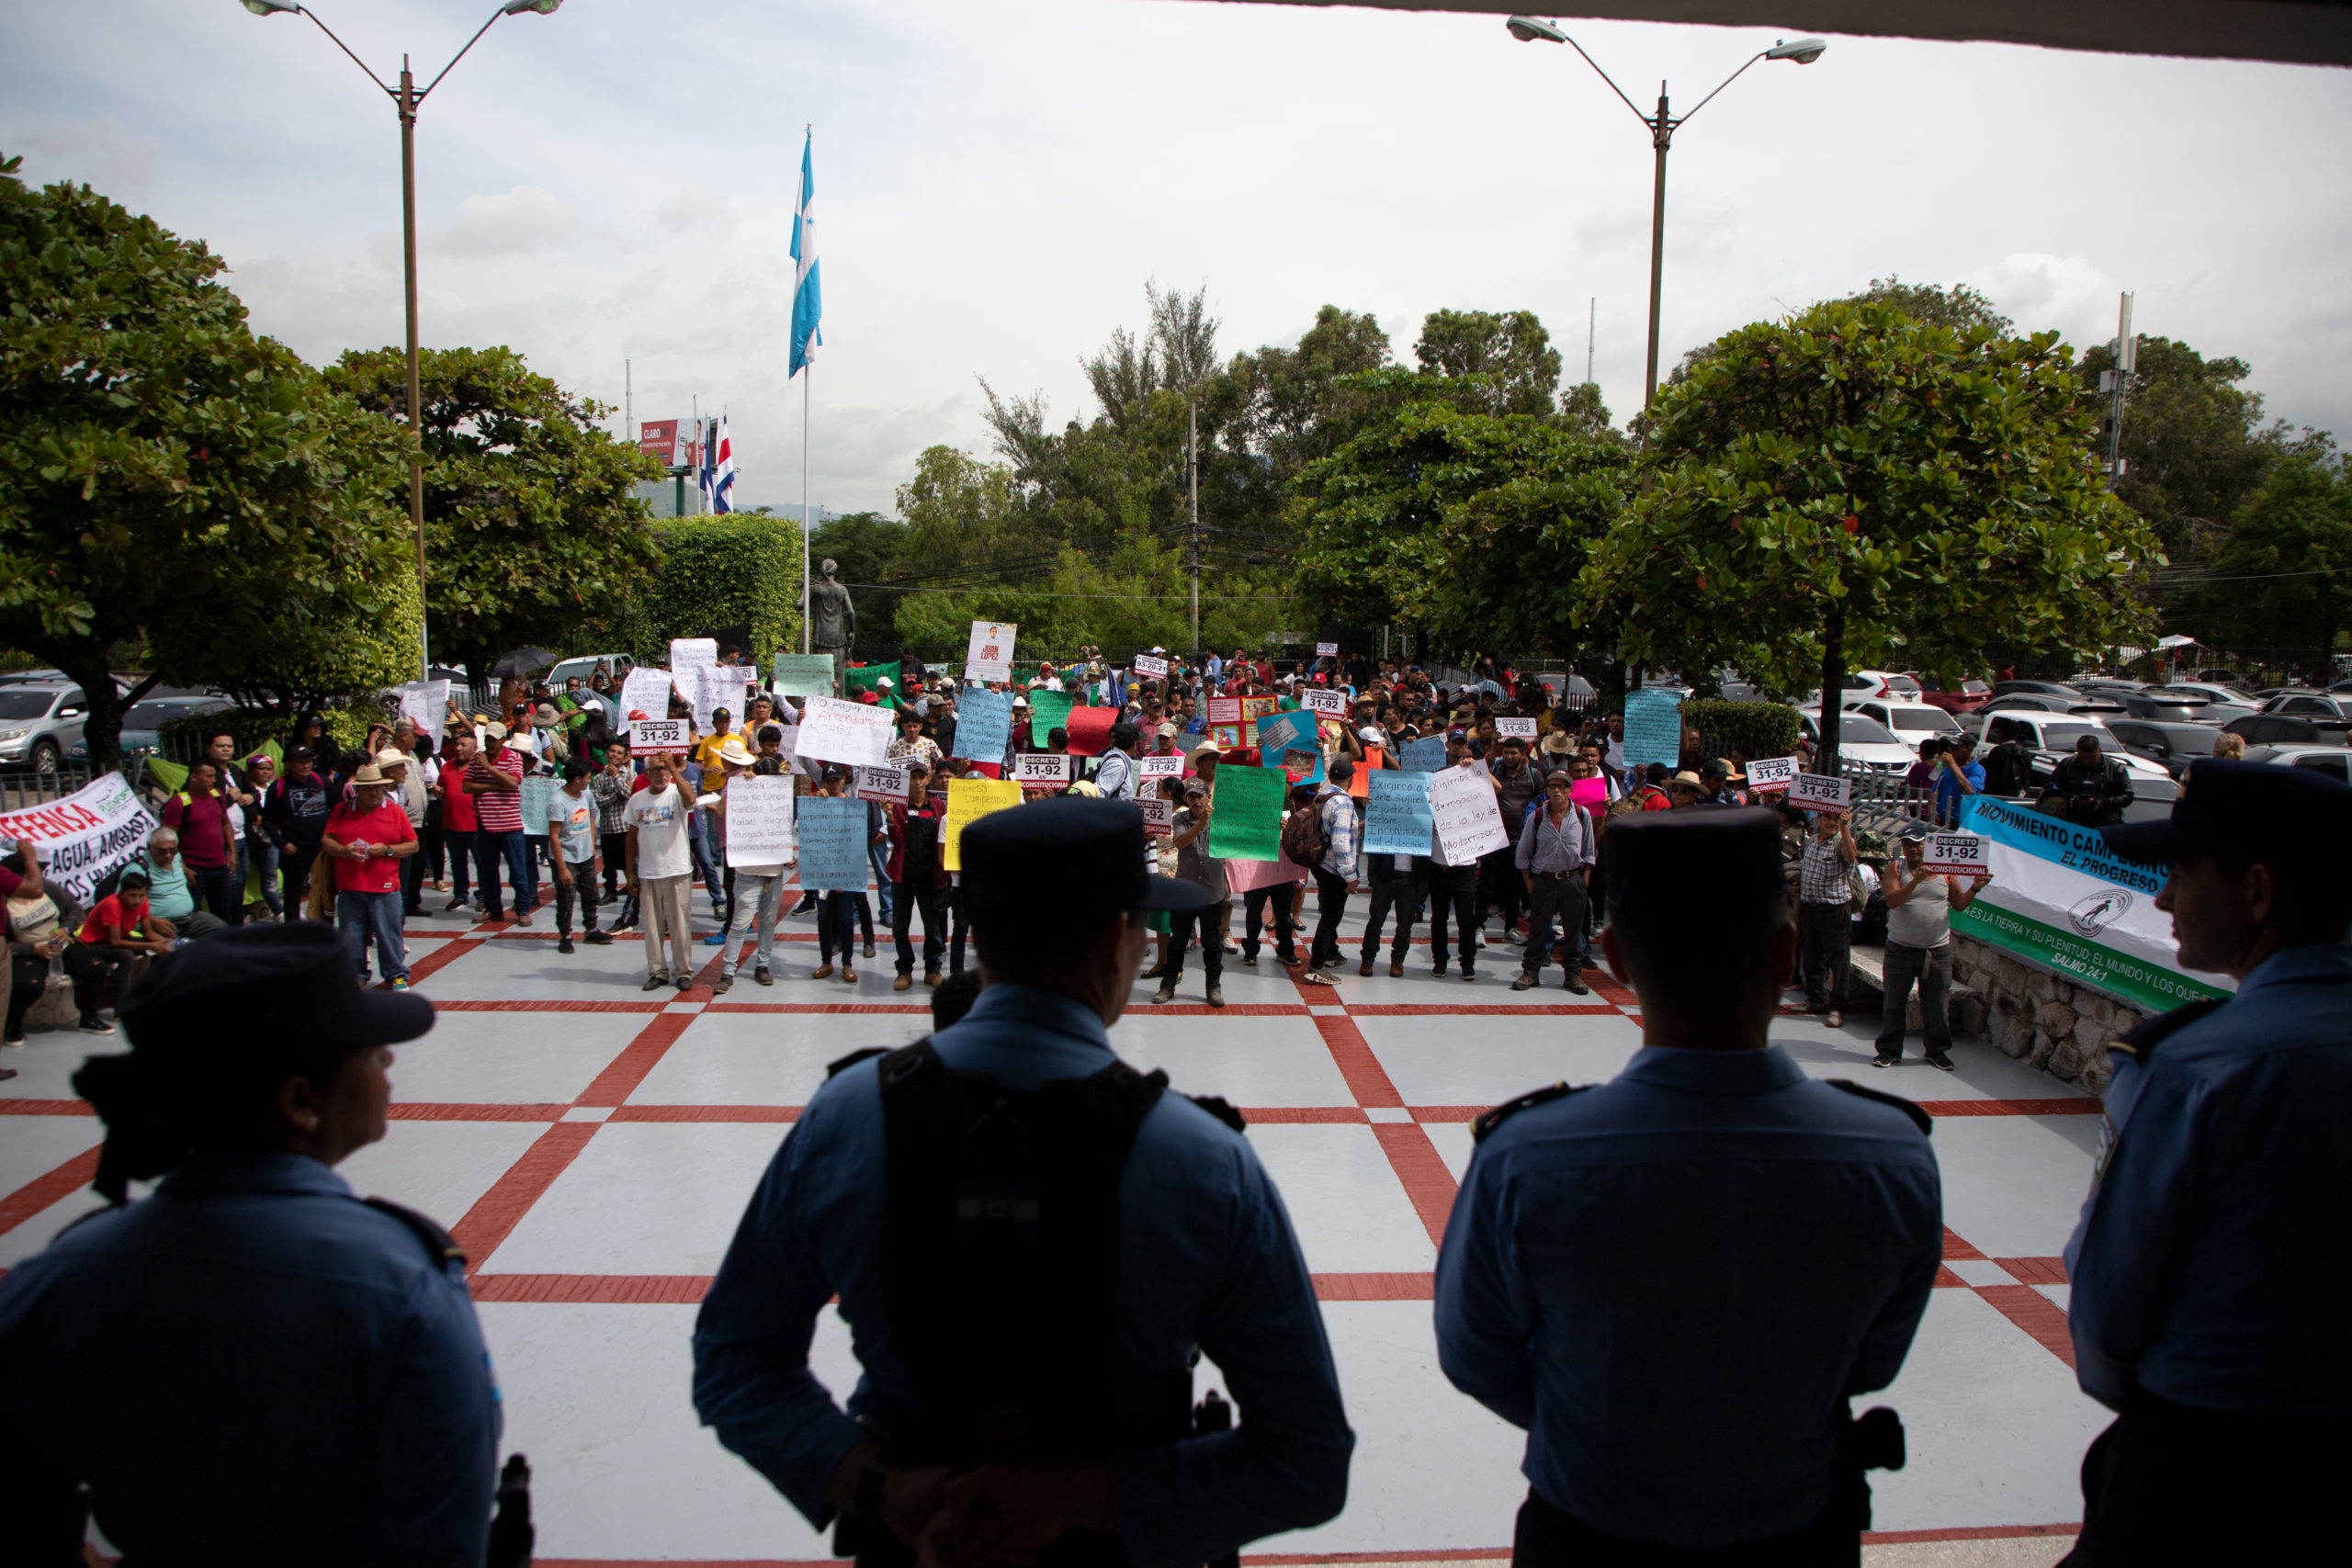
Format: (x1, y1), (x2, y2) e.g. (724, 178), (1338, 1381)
(959, 795), (1216, 921)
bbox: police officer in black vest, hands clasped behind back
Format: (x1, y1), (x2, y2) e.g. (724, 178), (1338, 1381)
(694, 797), (1355, 1568)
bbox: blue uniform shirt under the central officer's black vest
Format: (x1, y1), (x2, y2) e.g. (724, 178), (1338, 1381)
(694, 985), (1355, 1568)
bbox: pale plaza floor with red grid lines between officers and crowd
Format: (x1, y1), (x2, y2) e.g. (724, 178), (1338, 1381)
(0, 896), (2105, 1568)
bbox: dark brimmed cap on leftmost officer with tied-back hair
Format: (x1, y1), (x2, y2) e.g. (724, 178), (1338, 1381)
(118, 919), (433, 1054)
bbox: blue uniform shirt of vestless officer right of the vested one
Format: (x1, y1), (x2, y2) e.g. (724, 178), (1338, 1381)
(1437, 1046), (1943, 1547)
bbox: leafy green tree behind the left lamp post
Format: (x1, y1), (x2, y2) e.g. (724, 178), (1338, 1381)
(327, 348), (661, 682)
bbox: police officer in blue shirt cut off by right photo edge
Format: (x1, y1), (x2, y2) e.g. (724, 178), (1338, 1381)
(2065, 761), (2352, 1568)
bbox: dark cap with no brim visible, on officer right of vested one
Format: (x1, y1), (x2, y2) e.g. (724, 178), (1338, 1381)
(1601, 807), (1788, 926)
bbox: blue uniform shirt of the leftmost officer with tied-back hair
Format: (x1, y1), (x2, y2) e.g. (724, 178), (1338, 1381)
(0, 1155), (499, 1565)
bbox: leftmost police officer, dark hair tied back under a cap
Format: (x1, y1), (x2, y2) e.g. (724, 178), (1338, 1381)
(0, 921), (520, 1565)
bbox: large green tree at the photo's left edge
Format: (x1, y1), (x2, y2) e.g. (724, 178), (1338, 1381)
(0, 160), (404, 769)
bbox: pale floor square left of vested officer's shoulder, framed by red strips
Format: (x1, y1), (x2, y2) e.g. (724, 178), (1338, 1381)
(482, 1122), (790, 1274)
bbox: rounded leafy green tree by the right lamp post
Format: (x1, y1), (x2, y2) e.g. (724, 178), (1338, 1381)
(1583, 301), (2164, 766)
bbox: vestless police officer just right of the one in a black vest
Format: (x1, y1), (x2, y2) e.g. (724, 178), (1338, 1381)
(1437, 807), (1943, 1568)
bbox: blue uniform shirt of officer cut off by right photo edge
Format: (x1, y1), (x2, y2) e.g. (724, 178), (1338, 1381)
(2065, 942), (2352, 1417)
